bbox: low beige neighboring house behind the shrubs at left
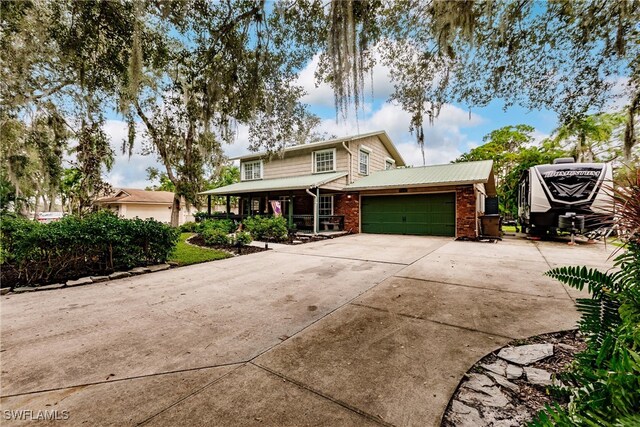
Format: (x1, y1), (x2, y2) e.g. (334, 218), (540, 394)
(95, 188), (193, 224)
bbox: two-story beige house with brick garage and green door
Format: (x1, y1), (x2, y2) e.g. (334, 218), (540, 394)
(201, 131), (496, 238)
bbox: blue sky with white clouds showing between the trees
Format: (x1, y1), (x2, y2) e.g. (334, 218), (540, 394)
(106, 56), (624, 188)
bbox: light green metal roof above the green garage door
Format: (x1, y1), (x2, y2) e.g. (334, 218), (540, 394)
(345, 160), (495, 193)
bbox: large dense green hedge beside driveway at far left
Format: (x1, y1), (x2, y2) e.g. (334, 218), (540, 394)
(0, 211), (179, 286)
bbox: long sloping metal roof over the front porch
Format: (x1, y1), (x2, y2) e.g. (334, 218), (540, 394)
(200, 172), (347, 195)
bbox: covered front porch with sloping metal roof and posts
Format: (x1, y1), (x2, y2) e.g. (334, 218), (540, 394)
(200, 173), (353, 234)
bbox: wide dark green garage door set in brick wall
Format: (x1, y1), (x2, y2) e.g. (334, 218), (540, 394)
(361, 193), (456, 236)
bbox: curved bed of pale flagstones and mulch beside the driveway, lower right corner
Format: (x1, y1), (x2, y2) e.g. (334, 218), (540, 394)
(441, 330), (586, 427)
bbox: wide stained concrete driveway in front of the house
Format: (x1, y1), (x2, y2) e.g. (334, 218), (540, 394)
(0, 234), (612, 426)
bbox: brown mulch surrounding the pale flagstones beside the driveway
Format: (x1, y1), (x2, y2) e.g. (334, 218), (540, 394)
(442, 330), (586, 427)
